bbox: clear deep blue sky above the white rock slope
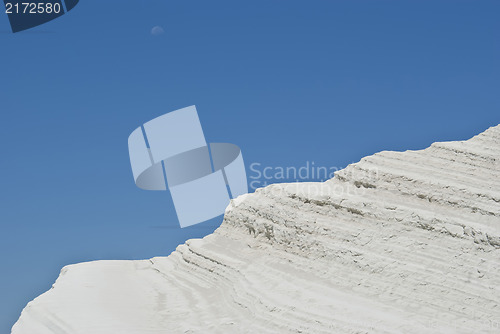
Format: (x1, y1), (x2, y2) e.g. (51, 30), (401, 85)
(0, 0), (500, 333)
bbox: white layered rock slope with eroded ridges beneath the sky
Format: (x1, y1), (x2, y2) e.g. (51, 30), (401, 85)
(12, 126), (500, 334)
